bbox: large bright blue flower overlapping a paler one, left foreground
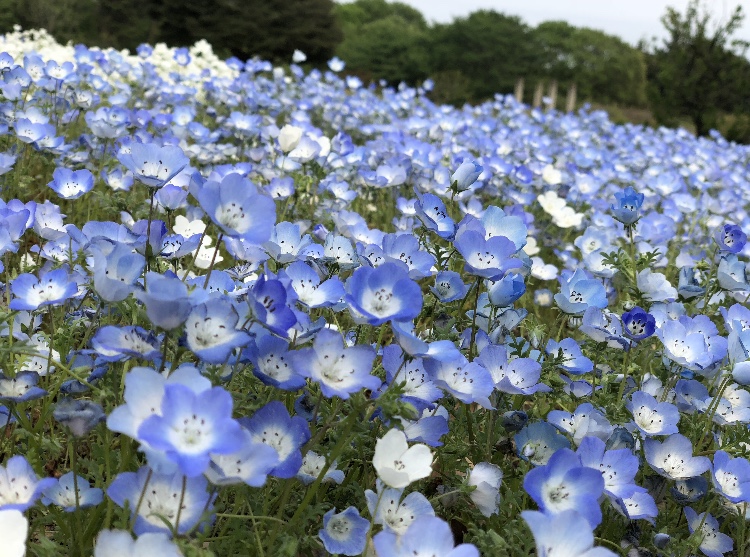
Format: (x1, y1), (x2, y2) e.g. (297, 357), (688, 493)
(138, 384), (243, 478)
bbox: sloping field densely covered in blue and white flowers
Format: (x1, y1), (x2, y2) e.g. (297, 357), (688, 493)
(0, 28), (750, 557)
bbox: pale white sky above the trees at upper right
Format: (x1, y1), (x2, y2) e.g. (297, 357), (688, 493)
(339, 0), (750, 45)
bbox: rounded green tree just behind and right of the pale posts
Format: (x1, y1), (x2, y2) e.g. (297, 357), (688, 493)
(533, 21), (646, 106)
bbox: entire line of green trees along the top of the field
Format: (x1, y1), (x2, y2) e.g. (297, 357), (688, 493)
(0, 0), (750, 142)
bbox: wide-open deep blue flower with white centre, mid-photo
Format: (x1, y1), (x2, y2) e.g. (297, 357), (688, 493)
(344, 263), (422, 325)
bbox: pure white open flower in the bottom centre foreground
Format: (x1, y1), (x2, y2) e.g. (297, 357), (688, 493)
(372, 429), (432, 488)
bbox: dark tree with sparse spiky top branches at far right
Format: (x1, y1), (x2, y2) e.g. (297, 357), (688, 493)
(648, 0), (750, 135)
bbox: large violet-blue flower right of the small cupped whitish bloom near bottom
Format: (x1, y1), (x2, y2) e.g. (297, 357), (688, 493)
(523, 449), (604, 528)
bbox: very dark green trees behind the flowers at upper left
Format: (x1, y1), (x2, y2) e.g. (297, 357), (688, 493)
(0, 0), (342, 64)
